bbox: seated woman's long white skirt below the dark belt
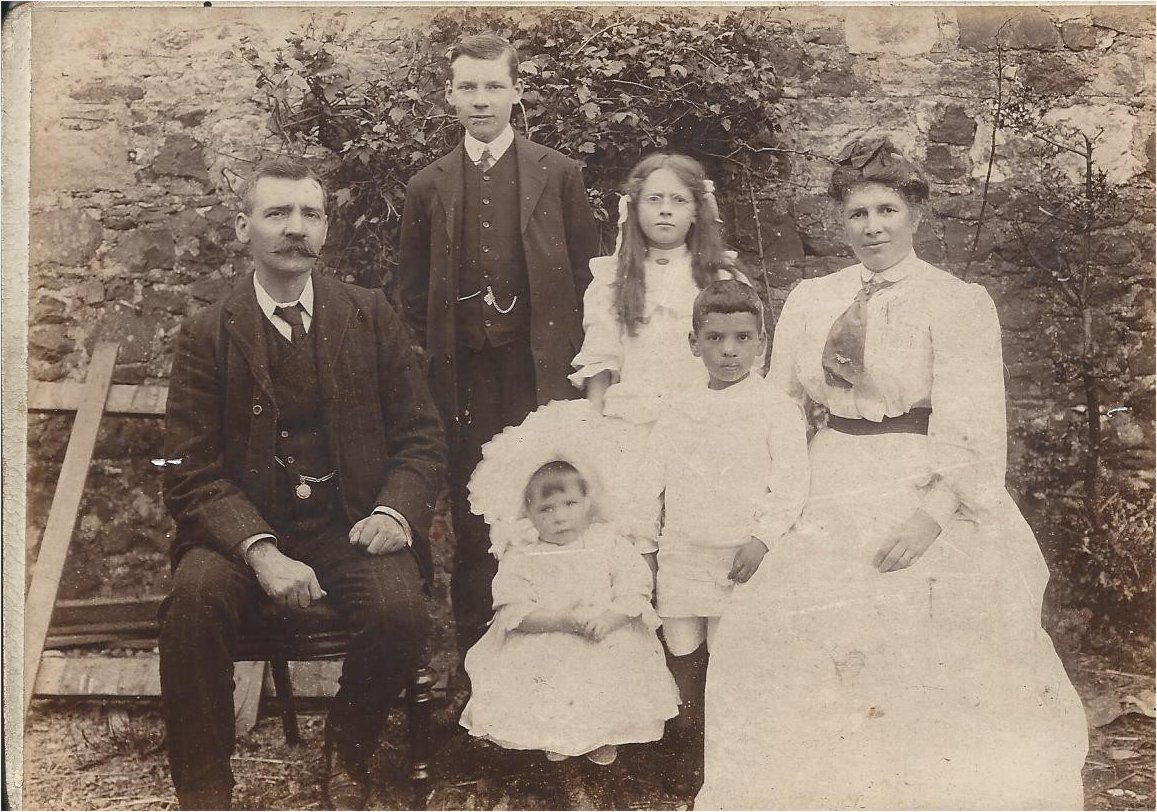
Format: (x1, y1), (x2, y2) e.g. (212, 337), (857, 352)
(695, 430), (1088, 810)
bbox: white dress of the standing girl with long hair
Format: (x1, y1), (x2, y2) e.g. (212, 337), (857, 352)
(570, 246), (728, 423)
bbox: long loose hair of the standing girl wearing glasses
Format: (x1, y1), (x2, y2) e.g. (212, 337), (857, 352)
(614, 153), (731, 335)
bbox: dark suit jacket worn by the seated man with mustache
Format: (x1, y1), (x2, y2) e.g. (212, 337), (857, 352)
(164, 272), (445, 578)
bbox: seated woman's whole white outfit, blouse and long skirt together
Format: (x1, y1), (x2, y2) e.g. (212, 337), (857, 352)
(695, 256), (1088, 810)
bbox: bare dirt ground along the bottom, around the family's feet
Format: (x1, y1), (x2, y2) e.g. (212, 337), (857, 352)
(24, 656), (1155, 810)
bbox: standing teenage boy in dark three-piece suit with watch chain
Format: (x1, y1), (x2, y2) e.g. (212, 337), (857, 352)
(398, 35), (598, 655)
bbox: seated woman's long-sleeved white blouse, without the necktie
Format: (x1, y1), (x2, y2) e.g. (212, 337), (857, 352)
(767, 254), (1008, 526)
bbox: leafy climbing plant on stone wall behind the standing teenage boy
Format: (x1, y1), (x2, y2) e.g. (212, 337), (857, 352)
(241, 9), (783, 285)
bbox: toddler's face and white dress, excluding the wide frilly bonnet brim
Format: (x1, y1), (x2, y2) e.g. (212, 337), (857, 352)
(460, 460), (678, 765)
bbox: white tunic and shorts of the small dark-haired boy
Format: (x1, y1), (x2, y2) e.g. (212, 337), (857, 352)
(643, 372), (808, 618)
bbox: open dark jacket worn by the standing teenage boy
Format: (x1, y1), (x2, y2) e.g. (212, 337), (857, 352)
(398, 134), (598, 425)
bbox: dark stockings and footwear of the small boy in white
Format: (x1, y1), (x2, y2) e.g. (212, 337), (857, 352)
(663, 643), (707, 797)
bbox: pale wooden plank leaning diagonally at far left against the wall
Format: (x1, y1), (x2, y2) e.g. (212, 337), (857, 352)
(24, 341), (118, 718)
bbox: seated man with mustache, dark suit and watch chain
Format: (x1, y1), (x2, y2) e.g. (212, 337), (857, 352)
(161, 158), (445, 810)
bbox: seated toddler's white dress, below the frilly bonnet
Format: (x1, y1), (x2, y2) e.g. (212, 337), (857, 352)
(462, 523), (678, 755)
